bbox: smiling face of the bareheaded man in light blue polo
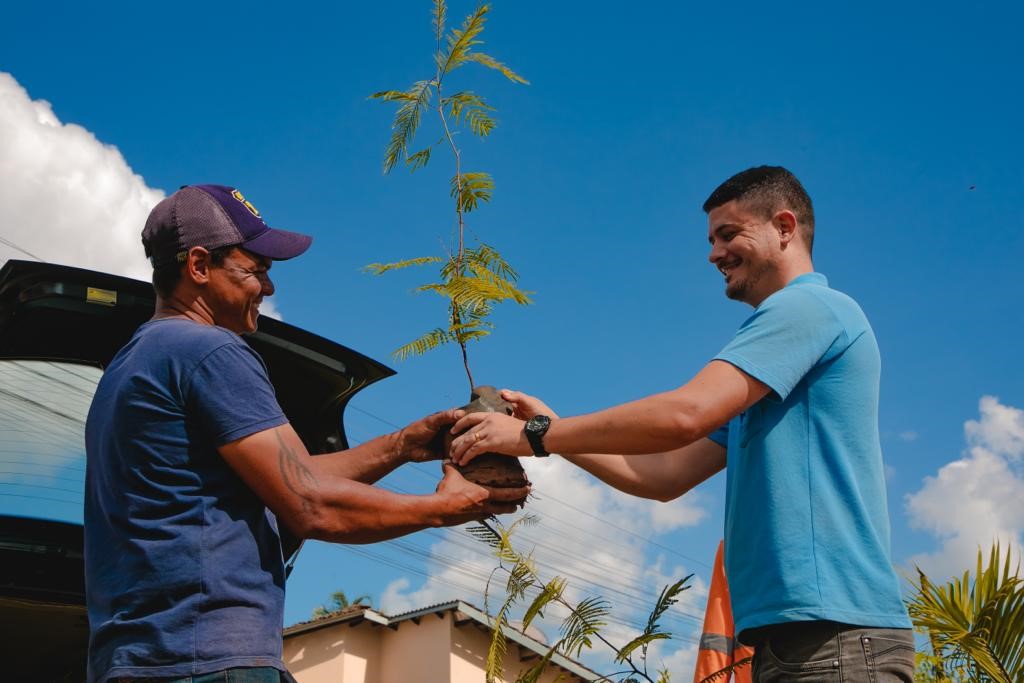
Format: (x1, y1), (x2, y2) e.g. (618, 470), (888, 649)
(708, 201), (785, 306)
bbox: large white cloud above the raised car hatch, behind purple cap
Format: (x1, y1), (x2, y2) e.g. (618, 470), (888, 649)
(0, 72), (164, 280)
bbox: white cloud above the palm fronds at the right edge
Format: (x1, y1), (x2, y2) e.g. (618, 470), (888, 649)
(906, 396), (1024, 581)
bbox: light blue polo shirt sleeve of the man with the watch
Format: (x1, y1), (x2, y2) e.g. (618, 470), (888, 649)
(715, 288), (846, 400)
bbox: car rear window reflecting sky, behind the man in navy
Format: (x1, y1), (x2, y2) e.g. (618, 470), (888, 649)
(0, 360), (102, 524)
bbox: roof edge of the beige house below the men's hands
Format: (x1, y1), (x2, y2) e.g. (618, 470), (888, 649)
(284, 600), (601, 681)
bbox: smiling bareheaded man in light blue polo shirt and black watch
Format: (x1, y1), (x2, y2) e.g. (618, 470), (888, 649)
(453, 166), (913, 681)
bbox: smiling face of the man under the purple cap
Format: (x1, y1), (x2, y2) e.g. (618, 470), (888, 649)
(204, 248), (273, 335)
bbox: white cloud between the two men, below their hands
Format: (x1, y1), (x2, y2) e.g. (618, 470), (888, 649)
(381, 457), (707, 675)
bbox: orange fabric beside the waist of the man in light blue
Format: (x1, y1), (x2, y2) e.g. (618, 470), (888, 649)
(693, 541), (754, 683)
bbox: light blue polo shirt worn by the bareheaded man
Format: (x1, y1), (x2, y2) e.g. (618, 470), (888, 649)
(711, 272), (910, 633)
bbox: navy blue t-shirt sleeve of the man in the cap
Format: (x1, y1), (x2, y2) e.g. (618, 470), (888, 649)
(185, 343), (288, 446)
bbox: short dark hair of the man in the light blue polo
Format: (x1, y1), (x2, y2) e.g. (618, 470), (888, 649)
(703, 166), (814, 252)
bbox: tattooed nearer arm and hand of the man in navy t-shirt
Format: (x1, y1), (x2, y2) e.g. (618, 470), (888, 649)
(219, 424), (528, 543)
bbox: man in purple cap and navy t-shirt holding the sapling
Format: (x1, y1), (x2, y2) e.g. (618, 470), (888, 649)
(85, 185), (527, 683)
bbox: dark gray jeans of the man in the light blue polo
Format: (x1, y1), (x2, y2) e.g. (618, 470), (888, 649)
(743, 622), (914, 683)
